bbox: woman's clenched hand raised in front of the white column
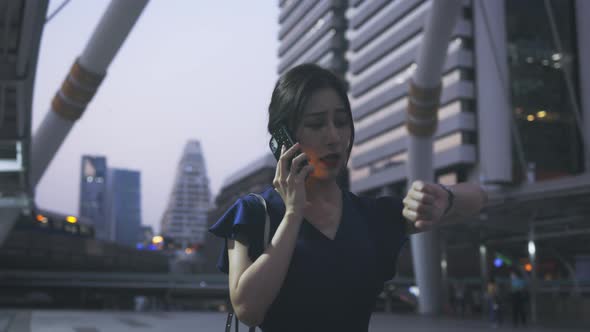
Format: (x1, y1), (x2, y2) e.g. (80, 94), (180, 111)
(402, 181), (449, 229)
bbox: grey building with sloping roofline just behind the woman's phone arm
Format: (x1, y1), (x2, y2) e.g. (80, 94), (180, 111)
(202, 153), (277, 273)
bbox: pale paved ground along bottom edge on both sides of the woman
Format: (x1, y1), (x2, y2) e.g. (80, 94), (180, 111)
(0, 310), (582, 332)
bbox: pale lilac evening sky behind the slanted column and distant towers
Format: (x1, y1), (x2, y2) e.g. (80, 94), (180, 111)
(32, 0), (279, 230)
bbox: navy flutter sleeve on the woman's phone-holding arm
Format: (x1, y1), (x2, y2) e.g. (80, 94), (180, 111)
(209, 195), (266, 273)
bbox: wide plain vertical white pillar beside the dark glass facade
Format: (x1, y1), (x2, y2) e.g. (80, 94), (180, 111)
(473, 0), (512, 184)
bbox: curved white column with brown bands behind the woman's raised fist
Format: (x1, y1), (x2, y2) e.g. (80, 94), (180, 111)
(406, 0), (462, 314)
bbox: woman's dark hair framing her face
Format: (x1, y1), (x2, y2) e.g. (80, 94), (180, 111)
(268, 63), (354, 162)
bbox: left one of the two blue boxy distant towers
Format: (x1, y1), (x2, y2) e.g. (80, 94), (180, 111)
(78, 156), (111, 240)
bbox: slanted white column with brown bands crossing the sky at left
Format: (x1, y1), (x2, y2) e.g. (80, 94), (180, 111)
(30, 0), (147, 188)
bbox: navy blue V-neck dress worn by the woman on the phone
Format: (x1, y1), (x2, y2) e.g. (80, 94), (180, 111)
(209, 186), (407, 332)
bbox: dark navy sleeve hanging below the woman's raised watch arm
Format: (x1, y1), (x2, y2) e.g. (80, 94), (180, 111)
(374, 196), (408, 281)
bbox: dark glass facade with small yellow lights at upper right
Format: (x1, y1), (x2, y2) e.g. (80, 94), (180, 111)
(505, 0), (583, 180)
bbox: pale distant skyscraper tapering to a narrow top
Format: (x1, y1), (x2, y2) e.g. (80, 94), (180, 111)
(161, 141), (211, 247)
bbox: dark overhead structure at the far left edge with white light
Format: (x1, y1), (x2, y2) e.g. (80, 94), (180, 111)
(0, 0), (48, 245)
